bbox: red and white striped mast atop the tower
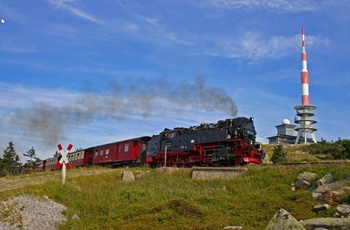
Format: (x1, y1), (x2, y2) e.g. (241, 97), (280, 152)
(301, 28), (310, 105)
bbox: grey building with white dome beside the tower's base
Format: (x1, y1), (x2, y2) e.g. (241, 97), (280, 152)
(267, 119), (297, 145)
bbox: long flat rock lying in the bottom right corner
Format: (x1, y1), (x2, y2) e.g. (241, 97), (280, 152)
(300, 217), (350, 230)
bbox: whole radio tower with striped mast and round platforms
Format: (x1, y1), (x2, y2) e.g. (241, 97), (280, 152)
(294, 28), (317, 144)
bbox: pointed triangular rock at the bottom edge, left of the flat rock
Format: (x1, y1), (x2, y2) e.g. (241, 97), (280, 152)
(266, 208), (305, 230)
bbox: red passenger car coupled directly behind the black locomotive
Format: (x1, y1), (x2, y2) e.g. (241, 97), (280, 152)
(92, 136), (150, 166)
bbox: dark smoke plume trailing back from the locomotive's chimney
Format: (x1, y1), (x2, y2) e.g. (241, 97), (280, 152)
(11, 78), (237, 146)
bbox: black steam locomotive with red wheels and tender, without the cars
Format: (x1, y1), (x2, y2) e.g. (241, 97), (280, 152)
(147, 117), (265, 167)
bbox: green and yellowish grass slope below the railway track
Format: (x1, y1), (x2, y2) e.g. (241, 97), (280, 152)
(0, 165), (348, 230)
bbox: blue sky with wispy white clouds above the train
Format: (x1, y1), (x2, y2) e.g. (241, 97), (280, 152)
(0, 0), (350, 162)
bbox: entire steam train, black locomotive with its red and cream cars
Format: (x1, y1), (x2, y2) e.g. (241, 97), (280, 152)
(39, 117), (265, 170)
